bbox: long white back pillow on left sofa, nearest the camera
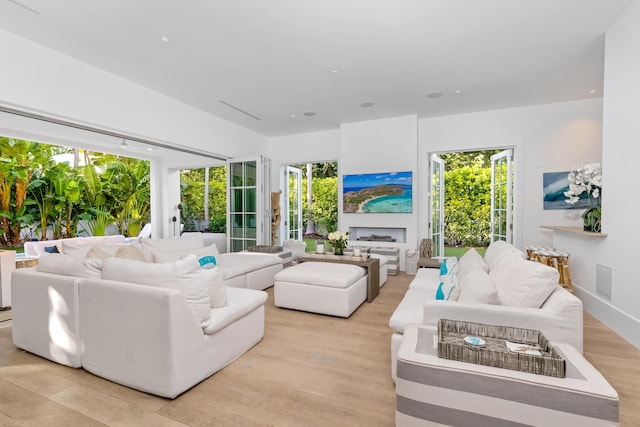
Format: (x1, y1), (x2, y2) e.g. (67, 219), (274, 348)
(102, 256), (211, 328)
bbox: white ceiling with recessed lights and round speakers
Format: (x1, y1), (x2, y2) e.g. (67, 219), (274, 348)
(0, 0), (631, 136)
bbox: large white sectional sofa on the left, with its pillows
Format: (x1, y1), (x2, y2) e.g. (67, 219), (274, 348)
(12, 236), (282, 398)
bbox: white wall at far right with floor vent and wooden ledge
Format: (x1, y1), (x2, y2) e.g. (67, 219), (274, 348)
(556, 0), (640, 348)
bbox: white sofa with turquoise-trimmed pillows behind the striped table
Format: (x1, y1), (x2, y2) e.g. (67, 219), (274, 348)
(389, 241), (583, 379)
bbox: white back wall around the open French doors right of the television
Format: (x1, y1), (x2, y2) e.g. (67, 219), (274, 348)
(418, 98), (602, 247)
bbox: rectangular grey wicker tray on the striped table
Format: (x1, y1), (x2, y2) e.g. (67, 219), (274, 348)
(438, 319), (566, 378)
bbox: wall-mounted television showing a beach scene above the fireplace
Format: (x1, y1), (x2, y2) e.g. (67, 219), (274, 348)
(342, 172), (413, 213)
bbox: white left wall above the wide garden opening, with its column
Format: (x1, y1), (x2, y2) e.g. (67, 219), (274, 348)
(0, 30), (267, 236)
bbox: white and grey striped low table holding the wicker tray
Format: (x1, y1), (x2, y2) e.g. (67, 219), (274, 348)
(396, 325), (619, 427)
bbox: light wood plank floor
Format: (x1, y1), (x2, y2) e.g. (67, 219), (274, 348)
(0, 273), (640, 427)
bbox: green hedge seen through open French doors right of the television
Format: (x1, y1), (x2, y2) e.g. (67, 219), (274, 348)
(444, 162), (491, 246)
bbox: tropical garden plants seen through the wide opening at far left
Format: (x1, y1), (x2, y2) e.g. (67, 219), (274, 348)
(0, 137), (150, 247)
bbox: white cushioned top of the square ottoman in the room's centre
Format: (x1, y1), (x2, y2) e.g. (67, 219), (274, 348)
(275, 262), (365, 288)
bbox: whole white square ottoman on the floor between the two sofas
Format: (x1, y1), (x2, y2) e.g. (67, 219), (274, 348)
(273, 262), (367, 317)
